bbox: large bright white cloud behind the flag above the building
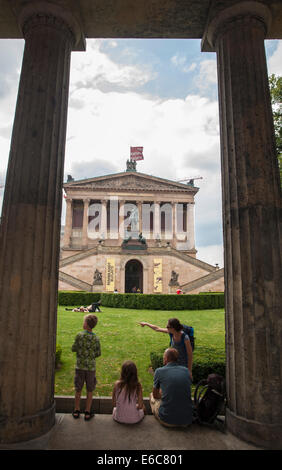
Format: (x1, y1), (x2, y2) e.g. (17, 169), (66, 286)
(66, 89), (219, 182)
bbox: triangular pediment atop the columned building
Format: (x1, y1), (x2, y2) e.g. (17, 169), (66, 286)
(64, 172), (198, 194)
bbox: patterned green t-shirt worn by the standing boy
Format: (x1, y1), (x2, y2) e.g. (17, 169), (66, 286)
(71, 330), (101, 370)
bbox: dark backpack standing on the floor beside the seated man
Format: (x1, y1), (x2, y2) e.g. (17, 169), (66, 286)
(194, 374), (226, 424)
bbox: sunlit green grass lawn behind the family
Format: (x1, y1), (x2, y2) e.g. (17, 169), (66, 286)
(55, 306), (225, 397)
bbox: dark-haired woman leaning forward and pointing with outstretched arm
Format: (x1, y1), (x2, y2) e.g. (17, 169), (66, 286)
(140, 318), (193, 379)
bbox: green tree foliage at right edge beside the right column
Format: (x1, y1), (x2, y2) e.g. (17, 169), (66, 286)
(269, 73), (282, 185)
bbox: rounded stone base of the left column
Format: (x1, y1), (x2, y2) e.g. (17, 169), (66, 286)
(0, 402), (56, 444)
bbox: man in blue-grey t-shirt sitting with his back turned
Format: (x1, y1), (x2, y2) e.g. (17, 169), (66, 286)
(150, 348), (193, 426)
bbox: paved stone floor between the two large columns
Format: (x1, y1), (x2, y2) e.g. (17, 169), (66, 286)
(0, 413), (258, 451)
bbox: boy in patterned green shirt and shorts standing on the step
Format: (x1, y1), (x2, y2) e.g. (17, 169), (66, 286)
(71, 314), (101, 421)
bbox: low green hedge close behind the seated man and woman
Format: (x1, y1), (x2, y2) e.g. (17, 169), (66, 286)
(150, 347), (225, 384)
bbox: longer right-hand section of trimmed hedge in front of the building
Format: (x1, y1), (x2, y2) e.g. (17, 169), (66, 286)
(101, 293), (224, 310)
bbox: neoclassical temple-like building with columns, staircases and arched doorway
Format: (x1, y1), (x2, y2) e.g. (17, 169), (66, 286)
(59, 162), (224, 294)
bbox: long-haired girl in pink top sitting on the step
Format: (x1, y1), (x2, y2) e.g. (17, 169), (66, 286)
(112, 361), (145, 424)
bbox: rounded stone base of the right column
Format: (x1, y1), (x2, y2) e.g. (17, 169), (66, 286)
(225, 409), (282, 450)
